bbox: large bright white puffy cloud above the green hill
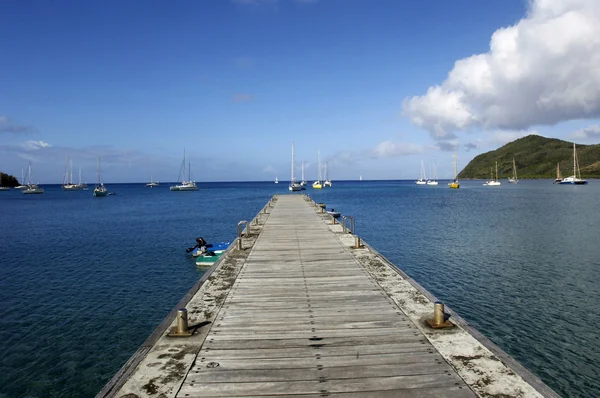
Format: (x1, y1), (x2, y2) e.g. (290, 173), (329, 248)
(402, 0), (600, 140)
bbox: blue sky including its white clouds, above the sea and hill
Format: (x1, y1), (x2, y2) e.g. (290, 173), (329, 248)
(0, 0), (600, 183)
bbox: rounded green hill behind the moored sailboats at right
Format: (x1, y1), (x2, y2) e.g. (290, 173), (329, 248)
(458, 135), (600, 179)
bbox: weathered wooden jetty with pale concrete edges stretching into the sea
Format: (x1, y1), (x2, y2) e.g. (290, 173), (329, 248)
(99, 195), (556, 397)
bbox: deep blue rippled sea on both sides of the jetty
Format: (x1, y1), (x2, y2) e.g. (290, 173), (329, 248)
(0, 180), (600, 398)
